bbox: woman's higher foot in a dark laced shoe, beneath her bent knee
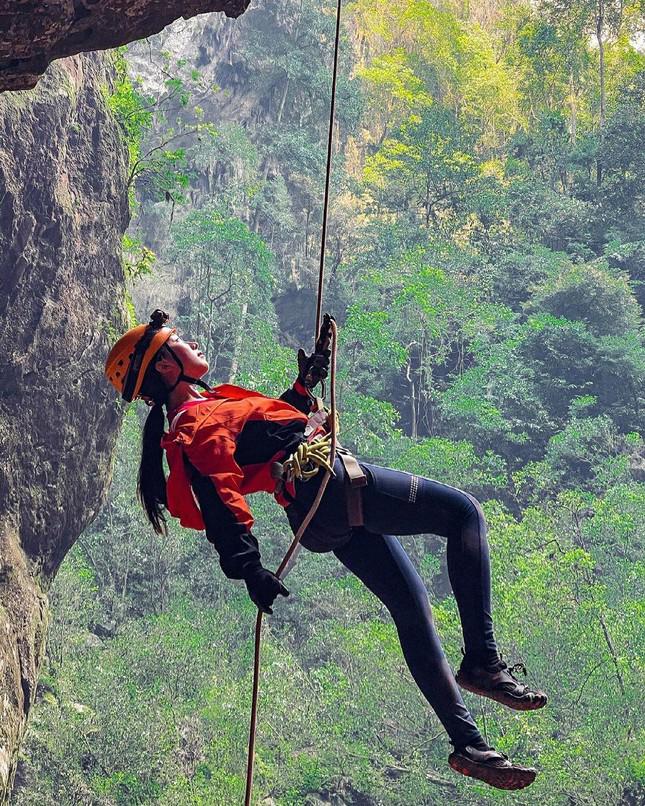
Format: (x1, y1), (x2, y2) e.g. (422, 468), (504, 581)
(455, 658), (547, 711)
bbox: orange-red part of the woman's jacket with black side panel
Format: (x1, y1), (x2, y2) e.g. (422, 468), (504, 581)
(161, 383), (310, 542)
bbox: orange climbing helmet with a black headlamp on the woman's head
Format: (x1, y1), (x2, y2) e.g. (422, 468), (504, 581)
(105, 309), (176, 402)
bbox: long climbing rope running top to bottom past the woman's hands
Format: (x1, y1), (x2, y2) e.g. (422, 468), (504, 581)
(244, 0), (342, 806)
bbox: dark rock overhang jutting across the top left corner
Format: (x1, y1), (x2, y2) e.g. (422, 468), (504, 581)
(0, 0), (249, 91)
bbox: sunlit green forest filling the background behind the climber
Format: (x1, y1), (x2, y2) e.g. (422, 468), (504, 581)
(15, 0), (645, 806)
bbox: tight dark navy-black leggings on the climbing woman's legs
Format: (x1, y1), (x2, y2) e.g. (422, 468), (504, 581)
(287, 460), (497, 746)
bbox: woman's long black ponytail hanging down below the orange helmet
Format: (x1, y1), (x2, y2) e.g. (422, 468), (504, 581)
(137, 344), (168, 535)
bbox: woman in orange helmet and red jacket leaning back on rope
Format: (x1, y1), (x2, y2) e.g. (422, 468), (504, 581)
(106, 310), (546, 789)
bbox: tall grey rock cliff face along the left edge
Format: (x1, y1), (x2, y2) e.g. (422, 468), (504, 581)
(0, 52), (129, 802)
